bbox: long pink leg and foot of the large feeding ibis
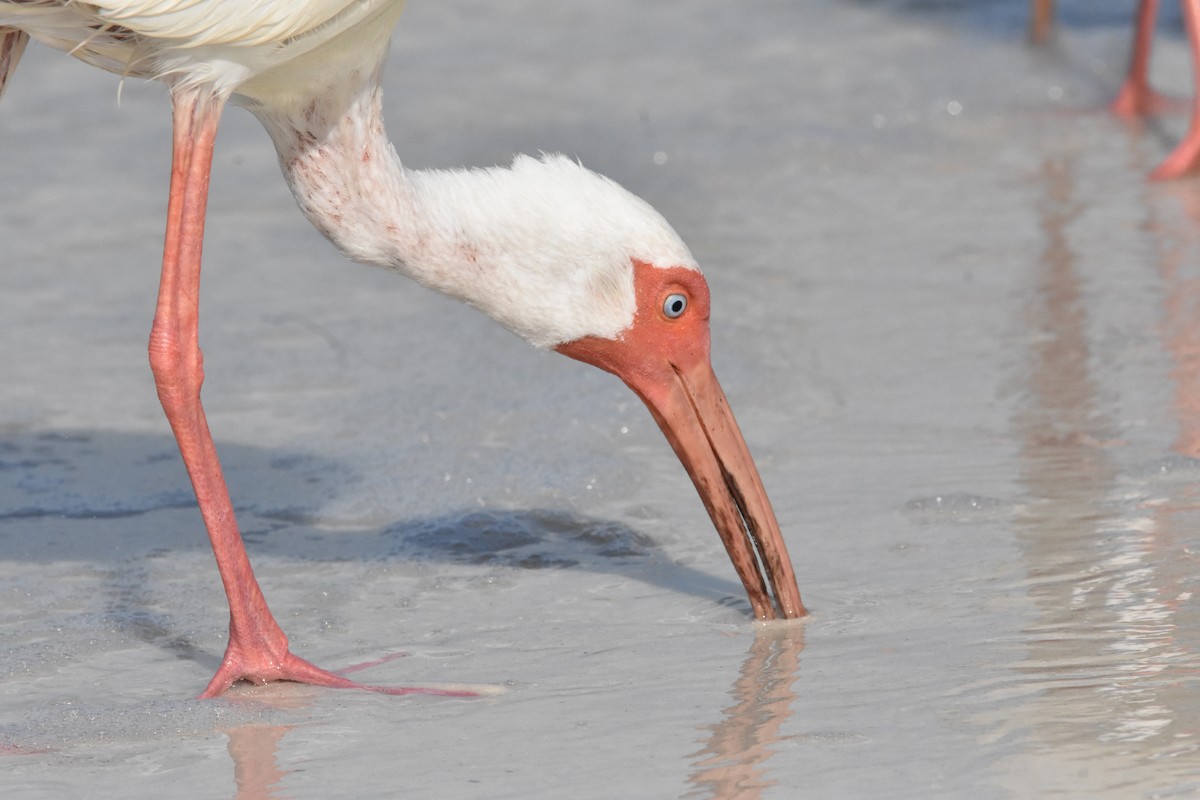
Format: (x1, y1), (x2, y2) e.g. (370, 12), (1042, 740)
(150, 90), (475, 697)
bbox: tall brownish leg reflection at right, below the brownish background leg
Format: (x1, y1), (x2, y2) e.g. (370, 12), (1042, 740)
(1015, 154), (1121, 745)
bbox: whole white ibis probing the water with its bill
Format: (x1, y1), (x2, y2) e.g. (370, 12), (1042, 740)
(0, 0), (805, 697)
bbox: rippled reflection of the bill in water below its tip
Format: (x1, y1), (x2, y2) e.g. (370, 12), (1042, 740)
(685, 622), (804, 800)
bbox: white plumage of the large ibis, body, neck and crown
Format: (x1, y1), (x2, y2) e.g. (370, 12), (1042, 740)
(0, 0), (696, 347)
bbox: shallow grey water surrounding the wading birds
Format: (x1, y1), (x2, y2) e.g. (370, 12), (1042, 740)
(0, 0), (1200, 799)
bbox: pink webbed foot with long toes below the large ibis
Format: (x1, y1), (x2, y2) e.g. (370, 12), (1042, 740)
(200, 633), (487, 698)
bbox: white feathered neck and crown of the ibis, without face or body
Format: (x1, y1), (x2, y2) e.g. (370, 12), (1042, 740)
(251, 74), (696, 348)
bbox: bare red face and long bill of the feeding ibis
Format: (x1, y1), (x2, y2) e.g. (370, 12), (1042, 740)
(556, 260), (806, 620)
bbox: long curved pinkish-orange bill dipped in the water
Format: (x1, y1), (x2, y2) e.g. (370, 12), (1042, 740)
(638, 359), (806, 620)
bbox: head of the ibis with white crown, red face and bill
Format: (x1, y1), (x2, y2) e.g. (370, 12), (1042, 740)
(415, 156), (804, 619)
